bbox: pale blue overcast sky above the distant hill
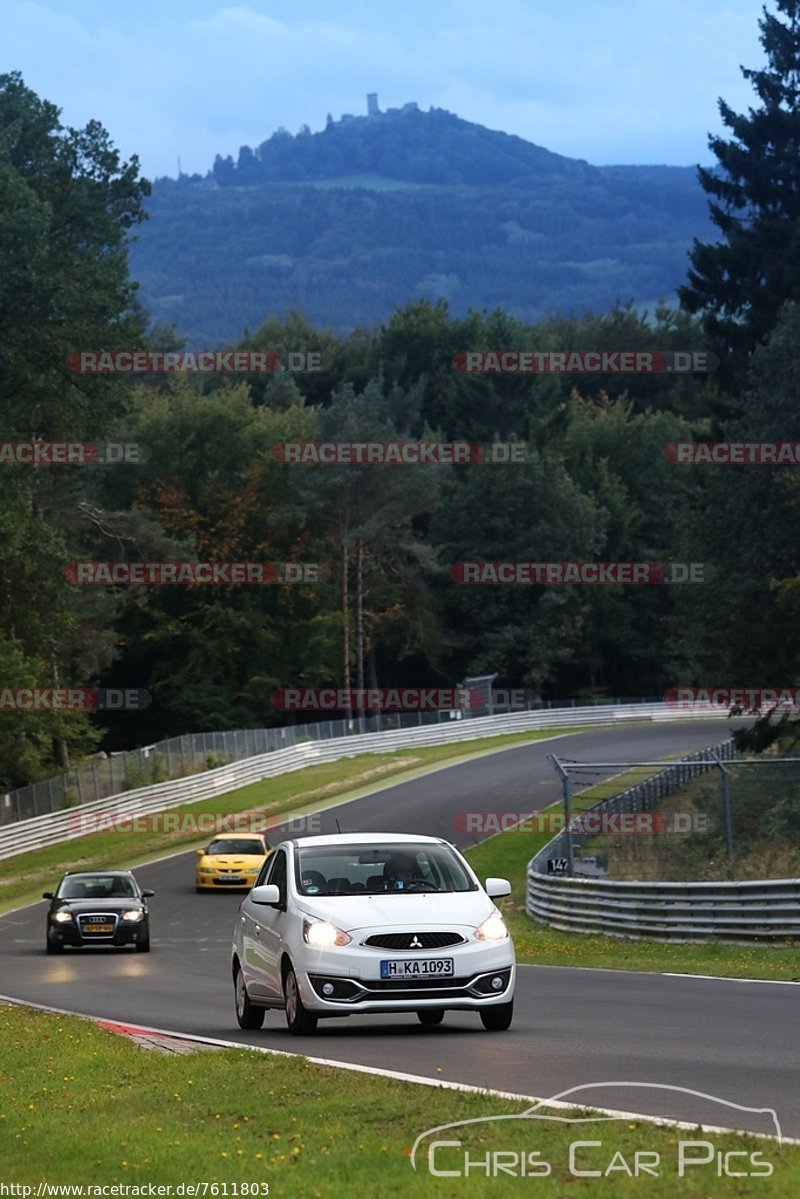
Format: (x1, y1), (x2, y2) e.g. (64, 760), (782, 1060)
(0, 0), (775, 177)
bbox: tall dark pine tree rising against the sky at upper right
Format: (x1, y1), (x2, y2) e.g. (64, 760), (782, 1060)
(679, 0), (800, 361)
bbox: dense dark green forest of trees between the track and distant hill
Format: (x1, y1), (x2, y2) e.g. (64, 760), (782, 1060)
(0, 0), (800, 789)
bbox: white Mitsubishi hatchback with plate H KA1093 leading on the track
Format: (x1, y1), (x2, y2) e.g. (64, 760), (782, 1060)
(233, 833), (516, 1035)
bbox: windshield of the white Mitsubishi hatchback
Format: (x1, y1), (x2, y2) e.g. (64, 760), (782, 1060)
(296, 843), (477, 896)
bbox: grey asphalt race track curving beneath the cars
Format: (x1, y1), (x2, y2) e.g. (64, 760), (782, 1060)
(0, 721), (800, 1137)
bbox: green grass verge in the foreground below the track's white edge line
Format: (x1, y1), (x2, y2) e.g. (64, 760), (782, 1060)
(0, 1006), (800, 1199)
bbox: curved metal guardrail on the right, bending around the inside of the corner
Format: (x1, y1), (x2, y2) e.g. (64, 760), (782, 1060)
(525, 742), (800, 942)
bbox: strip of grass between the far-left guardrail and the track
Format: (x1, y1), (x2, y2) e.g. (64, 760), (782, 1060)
(0, 728), (584, 912)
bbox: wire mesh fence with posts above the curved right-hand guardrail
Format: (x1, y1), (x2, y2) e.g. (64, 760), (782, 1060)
(546, 741), (800, 882)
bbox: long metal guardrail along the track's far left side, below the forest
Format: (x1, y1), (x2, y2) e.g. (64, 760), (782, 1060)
(0, 704), (728, 858)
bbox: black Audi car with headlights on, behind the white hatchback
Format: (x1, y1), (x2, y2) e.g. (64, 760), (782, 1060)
(43, 870), (154, 953)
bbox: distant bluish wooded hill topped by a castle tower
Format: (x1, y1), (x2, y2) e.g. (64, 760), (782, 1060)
(131, 104), (712, 347)
